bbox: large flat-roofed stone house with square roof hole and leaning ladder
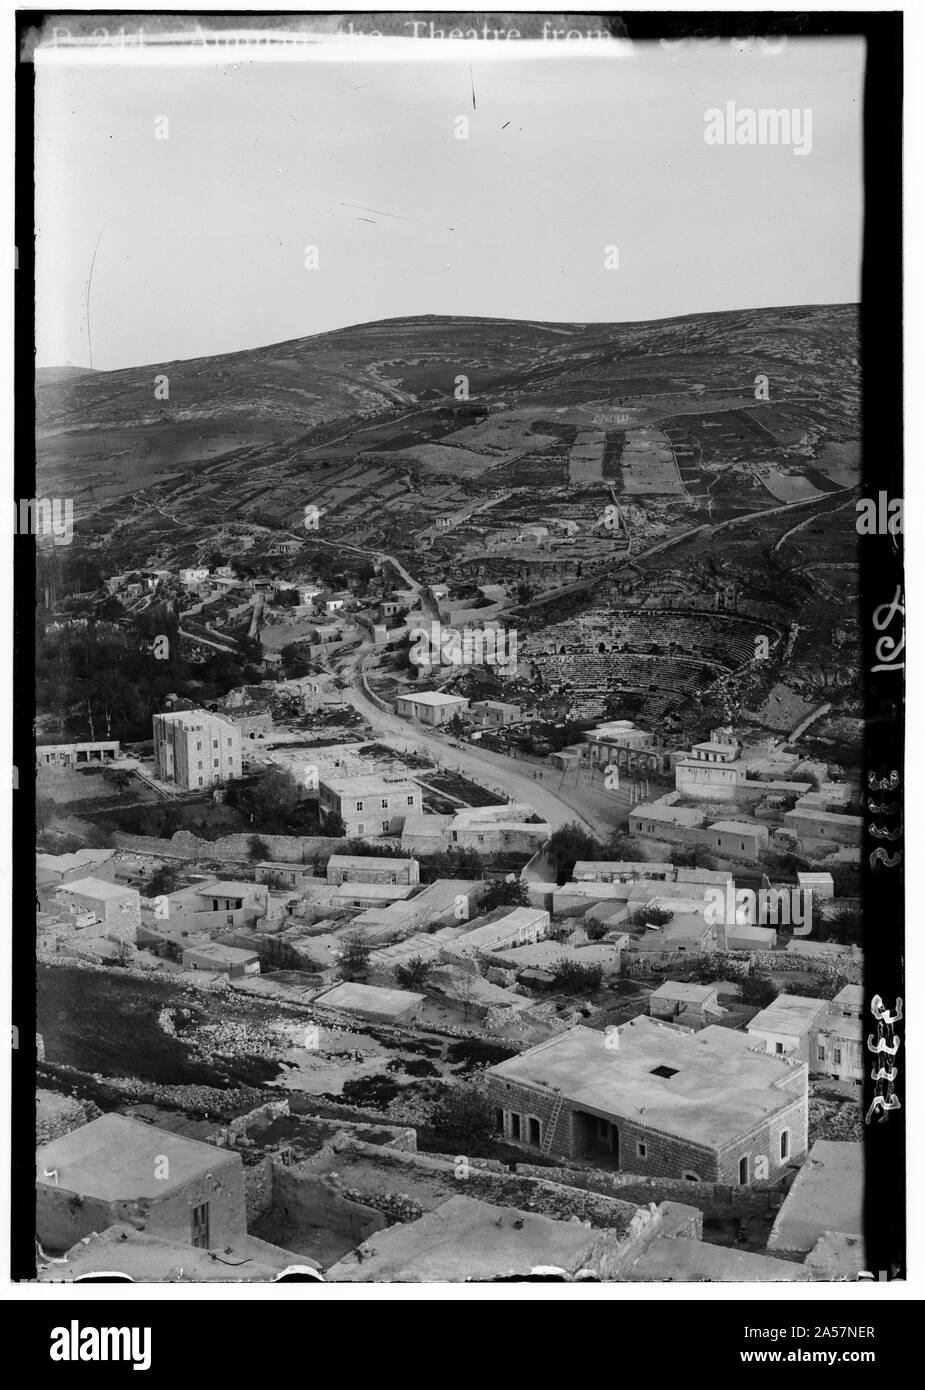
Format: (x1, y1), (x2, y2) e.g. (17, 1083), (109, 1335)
(485, 1016), (808, 1186)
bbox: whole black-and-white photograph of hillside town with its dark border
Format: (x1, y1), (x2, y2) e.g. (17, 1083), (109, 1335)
(13, 11), (906, 1312)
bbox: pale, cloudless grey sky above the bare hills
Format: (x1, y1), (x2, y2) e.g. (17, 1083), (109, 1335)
(35, 39), (864, 370)
